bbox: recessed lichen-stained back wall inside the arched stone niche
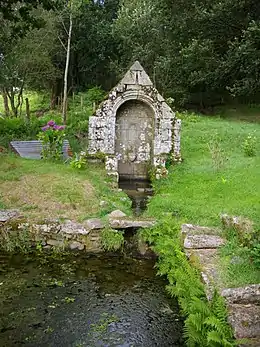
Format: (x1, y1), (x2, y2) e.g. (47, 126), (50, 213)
(115, 98), (155, 179)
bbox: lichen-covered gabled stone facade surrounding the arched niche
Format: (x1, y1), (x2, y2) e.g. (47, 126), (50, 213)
(88, 65), (181, 181)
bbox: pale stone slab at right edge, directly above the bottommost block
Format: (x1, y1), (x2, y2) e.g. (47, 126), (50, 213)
(221, 284), (260, 305)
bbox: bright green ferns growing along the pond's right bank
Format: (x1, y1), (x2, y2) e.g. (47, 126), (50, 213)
(140, 217), (235, 347)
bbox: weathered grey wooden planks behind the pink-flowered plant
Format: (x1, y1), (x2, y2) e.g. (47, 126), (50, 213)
(10, 140), (70, 159)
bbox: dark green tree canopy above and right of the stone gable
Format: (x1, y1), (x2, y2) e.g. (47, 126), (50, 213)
(115, 0), (260, 108)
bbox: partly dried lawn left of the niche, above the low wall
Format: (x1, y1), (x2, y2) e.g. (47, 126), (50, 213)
(0, 155), (131, 221)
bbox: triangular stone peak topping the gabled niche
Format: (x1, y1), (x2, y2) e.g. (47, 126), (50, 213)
(120, 61), (153, 86)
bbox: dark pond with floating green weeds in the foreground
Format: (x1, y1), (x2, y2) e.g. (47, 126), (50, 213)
(0, 252), (184, 347)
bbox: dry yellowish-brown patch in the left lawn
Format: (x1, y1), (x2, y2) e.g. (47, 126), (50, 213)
(0, 174), (98, 220)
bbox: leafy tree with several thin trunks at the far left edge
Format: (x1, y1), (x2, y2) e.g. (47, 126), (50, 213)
(0, 9), (61, 116)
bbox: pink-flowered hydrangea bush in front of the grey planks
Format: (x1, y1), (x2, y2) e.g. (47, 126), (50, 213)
(38, 120), (65, 161)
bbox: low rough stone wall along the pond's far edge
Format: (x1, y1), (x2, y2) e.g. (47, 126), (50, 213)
(0, 210), (155, 253)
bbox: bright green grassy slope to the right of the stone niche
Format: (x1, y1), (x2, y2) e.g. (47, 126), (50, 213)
(147, 116), (260, 227)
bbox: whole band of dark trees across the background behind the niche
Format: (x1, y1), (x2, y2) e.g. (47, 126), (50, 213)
(0, 0), (260, 110)
